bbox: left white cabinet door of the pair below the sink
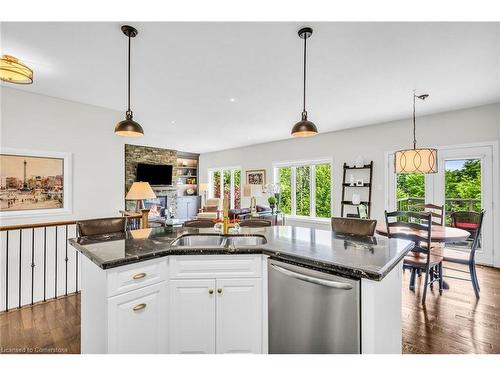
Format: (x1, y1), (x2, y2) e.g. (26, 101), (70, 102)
(169, 279), (216, 354)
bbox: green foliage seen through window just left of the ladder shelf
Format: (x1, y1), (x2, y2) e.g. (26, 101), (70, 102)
(278, 164), (331, 218)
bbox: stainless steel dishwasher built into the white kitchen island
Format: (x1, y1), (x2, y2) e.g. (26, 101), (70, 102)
(268, 259), (360, 354)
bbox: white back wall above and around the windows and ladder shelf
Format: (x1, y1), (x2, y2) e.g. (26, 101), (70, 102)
(200, 103), (500, 228)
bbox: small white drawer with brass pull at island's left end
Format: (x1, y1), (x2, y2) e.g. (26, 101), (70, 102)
(108, 259), (167, 297)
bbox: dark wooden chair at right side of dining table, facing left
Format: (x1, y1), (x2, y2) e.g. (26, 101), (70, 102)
(432, 210), (485, 298)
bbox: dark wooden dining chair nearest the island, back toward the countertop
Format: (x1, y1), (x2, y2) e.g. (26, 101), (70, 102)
(385, 211), (443, 305)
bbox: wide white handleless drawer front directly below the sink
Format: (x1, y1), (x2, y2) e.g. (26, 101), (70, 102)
(169, 255), (262, 279)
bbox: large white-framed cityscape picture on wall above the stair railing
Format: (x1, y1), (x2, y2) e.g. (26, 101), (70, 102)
(0, 148), (72, 218)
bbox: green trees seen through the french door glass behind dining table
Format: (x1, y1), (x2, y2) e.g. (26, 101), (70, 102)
(396, 159), (481, 219)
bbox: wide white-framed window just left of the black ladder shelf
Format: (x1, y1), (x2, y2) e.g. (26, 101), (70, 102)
(274, 160), (332, 218)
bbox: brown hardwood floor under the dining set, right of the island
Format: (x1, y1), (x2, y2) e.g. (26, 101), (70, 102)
(402, 262), (500, 354)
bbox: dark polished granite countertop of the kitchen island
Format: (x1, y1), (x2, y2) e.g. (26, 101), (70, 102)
(69, 226), (413, 280)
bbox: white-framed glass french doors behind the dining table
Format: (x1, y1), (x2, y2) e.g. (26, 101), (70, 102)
(386, 143), (500, 266)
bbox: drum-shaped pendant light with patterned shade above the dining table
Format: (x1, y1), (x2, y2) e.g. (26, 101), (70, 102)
(394, 91), (437, 174)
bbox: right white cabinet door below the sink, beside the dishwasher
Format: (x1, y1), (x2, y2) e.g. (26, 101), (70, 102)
(215, 279), (262, 353)
